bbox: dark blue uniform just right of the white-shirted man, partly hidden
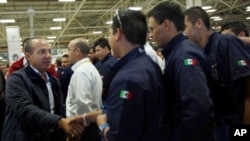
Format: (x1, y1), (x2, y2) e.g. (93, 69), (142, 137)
(98, 53), (117, 102)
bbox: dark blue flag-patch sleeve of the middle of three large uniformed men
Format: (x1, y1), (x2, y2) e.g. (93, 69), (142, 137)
(170, 55), (212, 141)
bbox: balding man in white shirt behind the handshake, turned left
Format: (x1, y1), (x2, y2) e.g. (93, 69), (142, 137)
(66, 38), (102, 141)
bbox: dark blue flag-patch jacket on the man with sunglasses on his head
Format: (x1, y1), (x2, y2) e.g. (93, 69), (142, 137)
(106, 46), (167, 141)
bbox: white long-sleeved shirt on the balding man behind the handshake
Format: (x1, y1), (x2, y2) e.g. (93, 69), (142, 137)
(66, 58), (102, 117)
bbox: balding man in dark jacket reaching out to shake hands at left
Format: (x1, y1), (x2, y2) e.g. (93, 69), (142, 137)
(2, 38), (83, 141)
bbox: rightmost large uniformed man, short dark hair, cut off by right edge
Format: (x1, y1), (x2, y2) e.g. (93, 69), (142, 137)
(184, 6), (250, 141)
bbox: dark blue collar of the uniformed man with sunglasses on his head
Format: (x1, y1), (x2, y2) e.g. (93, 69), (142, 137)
(112, 46), (145, 73)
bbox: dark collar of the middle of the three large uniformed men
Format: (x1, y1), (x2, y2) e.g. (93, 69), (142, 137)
(162, 33), (187, 58)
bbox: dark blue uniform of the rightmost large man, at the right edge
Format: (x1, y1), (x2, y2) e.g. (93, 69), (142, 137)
(205, 33), (250, 141)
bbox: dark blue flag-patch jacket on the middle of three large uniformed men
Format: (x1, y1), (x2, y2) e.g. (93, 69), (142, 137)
(162, 34), (214, 141)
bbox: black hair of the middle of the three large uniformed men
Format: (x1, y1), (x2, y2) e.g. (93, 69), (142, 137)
(148, 1), (184, 31)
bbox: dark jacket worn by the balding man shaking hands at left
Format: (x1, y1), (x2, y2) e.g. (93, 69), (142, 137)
(2, 66), (65, 141)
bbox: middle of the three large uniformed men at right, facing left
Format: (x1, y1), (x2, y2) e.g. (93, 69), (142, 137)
(148, 1), (213, 141)
